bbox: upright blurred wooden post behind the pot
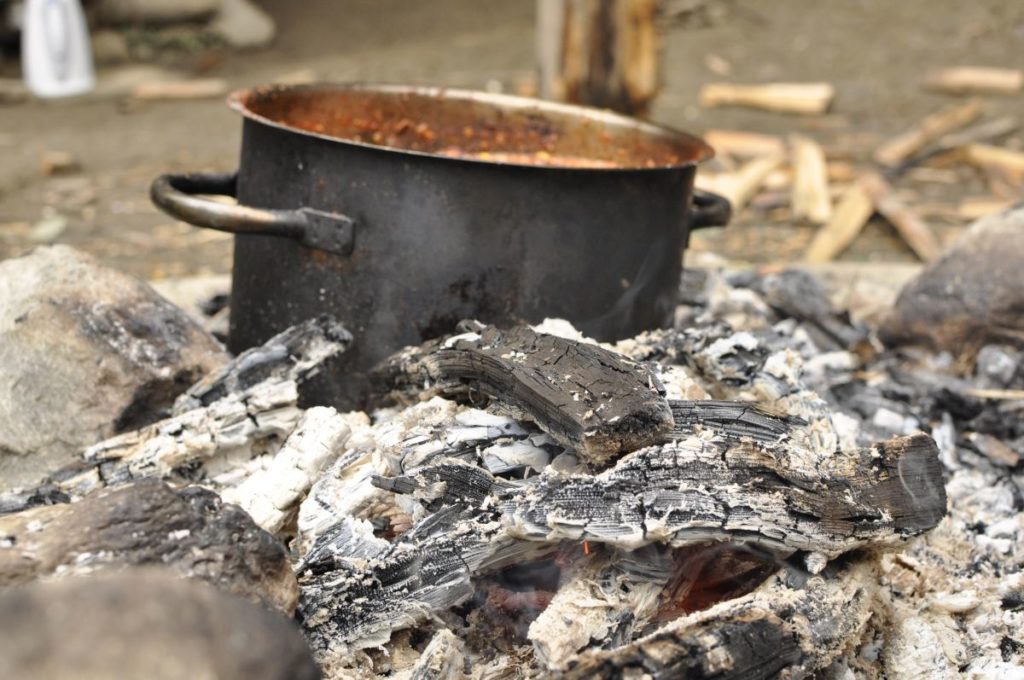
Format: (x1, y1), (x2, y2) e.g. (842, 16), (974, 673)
(537, 0), (659, 116)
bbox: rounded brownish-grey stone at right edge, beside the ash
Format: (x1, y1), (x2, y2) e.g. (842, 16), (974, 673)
(881, 204), (1024, 357)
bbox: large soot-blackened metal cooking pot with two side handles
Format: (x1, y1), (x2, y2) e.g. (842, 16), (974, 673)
(152, 85), (729, 408)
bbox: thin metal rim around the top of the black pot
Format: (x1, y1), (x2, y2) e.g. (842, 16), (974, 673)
(227, 83), (715, 173)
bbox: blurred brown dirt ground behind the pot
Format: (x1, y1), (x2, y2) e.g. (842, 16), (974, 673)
(0, 0), (1024, 279)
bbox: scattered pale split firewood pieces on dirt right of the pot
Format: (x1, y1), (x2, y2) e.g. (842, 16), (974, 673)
(697, 68), (1024, 262)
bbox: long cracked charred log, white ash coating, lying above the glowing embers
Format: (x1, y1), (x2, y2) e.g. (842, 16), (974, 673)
(495, 435), (946, 557)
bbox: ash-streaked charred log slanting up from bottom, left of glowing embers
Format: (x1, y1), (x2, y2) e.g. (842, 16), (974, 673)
(297, 503), (551, 663)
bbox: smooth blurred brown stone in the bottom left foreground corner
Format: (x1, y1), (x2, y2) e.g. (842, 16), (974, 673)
(0, 567), (321, 680)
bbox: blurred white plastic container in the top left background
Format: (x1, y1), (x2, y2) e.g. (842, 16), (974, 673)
(22, 0), (96, 97)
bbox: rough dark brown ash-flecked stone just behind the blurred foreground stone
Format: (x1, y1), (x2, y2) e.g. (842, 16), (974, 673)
(0, 479), (299, 614)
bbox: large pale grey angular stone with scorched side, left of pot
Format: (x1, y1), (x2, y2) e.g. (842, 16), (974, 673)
(0, 246), (228, 492)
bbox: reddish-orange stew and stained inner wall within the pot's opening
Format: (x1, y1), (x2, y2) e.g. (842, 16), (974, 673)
(232, 87), (712, 169)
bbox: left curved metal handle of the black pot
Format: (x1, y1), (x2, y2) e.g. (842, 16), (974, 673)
(150, 172), (355, 255)
